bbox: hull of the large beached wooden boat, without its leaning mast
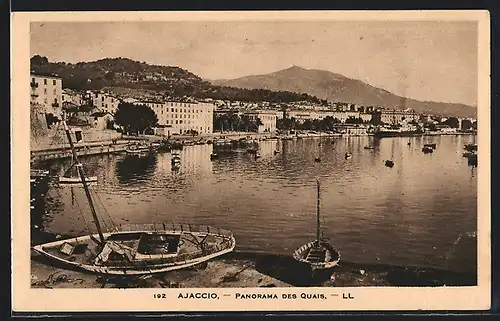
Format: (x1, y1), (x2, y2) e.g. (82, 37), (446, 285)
(33, 224), (236, 275)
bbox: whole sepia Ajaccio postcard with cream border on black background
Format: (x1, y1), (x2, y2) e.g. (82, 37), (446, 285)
(11, 11), (490, 310)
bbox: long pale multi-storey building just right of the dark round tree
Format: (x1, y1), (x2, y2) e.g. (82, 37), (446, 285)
(136, 101), (215, 136)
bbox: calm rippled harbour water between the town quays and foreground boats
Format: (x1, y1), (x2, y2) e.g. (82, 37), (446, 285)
(39, 136), (477, 272)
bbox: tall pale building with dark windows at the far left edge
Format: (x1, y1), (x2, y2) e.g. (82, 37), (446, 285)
(30, 73), (62, 118)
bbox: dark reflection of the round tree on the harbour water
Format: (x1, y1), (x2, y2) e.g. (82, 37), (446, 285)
(116, 153), (158, 184)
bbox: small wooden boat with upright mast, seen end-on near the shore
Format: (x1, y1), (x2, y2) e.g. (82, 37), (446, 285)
(293, 180), (340, 270)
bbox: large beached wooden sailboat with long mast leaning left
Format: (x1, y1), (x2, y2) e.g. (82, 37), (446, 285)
(33, 121), (236, 275)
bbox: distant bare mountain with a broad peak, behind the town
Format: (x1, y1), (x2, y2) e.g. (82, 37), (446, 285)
(212, 66), (477, 117)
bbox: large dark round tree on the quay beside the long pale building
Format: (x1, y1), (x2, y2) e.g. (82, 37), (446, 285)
(115, 103), (158, 134)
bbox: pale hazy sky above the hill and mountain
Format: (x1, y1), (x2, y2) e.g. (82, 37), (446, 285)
(31, 21), (478, 105)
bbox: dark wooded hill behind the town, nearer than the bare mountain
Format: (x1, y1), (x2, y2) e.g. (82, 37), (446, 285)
(30, 55), (321, 103)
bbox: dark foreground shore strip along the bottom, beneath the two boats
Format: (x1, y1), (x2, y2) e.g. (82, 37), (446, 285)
(31, 251), (477, 288)
